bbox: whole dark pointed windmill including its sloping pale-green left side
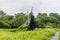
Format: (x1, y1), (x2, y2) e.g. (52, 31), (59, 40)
(17, 8), (35, 30)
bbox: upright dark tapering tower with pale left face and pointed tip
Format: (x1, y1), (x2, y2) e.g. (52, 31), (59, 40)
(28, 8), (35, 30)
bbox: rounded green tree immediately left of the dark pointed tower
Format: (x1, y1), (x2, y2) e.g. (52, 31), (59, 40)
(10, 13), (27, 28)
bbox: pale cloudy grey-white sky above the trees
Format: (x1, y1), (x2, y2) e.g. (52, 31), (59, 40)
(0, 0), (60, 15)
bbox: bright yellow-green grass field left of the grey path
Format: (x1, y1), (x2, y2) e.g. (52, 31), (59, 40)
(0, 29), (56, 40)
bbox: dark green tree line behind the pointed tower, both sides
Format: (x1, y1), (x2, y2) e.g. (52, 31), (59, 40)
(0, 10), (60, 28)
